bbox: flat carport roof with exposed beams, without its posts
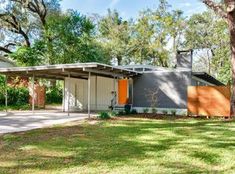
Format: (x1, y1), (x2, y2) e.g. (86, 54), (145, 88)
(0, 63), (141, 80)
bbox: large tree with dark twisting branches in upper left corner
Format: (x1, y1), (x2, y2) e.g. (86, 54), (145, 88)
(0, 0), (58, 54)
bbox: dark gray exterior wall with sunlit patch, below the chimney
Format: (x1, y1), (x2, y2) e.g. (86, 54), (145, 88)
(133, 71), (191, 109)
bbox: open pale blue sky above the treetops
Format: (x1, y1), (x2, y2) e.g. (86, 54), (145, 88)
(61, 0), (206, 19)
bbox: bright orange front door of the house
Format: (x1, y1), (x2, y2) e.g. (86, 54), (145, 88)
(118, 80), (128, 105)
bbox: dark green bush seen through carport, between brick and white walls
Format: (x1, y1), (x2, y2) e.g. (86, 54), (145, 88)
(46, 87), (63, 104)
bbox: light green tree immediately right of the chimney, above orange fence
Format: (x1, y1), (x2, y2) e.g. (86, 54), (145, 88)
(184, 10), (231, 84)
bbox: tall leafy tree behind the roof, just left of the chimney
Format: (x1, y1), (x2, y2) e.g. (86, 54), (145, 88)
(131, 0), (184, 67)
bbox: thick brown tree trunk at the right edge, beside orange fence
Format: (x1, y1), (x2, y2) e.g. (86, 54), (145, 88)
(228, 11), (235, 115)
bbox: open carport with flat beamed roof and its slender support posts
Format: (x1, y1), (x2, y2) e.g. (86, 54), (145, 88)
(0, 63), (140, 118)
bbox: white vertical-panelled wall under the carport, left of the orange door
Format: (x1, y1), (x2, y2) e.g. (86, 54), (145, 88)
(65, 76), (117, 111)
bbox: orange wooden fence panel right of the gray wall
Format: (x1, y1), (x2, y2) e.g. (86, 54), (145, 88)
(188, 86), (231, 117)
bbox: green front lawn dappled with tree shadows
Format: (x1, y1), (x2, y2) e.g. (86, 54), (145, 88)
(0, 118), (235, 174)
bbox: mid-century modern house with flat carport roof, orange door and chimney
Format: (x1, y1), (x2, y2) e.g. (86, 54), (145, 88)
(0, 51), (223, 114)
